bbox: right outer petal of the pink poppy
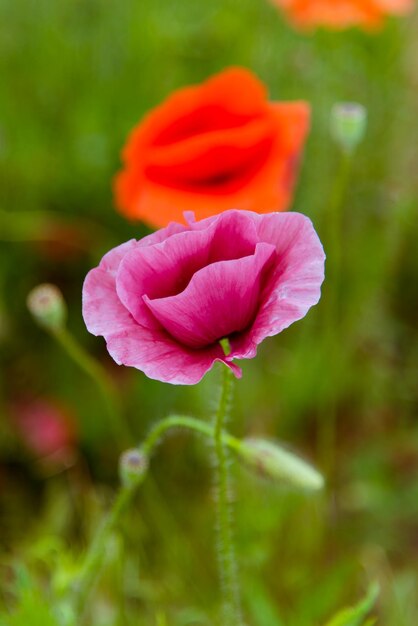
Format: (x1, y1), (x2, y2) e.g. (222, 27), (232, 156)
(229, 213), (325, 359)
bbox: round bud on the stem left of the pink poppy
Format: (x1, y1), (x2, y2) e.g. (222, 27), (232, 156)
(26, 283), (67, 330)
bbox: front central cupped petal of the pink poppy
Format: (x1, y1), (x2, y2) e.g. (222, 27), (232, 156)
(144, 243), (275, 348)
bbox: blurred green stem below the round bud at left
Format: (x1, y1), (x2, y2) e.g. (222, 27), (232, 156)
(51, 327), (132, 447)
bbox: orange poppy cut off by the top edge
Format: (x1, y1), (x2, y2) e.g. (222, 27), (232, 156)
(273, 0), (413, 29)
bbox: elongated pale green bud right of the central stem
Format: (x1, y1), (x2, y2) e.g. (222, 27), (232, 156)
(237, 439), (324, 491)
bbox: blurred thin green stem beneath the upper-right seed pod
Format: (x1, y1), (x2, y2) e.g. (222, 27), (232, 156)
(318, 152), (353, 478)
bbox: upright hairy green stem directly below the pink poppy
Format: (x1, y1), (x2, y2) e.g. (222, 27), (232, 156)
(213, 367), (242, 626)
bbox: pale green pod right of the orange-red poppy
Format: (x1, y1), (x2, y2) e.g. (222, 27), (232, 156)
(331, 102), (367, 153)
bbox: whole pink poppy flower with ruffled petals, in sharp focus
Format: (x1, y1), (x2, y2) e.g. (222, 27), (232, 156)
(83, 210), (325, 385)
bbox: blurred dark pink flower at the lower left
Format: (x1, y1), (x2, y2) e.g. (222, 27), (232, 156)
(14, 398), (76, 461)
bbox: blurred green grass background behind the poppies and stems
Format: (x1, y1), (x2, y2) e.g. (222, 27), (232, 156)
(0, 0), (418, 626)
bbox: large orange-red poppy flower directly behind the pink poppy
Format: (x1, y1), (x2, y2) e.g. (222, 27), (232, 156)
(115, 67), (309, 227)
